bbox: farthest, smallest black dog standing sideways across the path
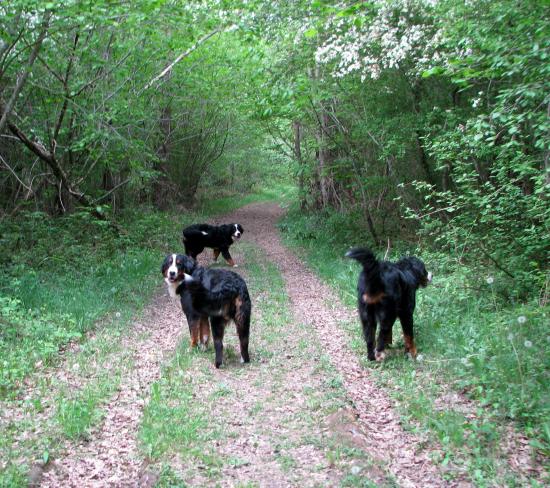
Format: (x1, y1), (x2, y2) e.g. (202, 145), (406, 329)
(183, 224), (244, 266)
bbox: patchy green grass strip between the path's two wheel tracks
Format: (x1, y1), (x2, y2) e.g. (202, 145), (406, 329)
(139, 243), (286, 480)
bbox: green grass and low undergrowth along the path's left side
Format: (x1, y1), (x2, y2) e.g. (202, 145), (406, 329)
(0, 204), (181, 396)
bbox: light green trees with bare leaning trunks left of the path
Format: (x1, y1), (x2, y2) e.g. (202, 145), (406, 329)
(0, 0), (282, 218)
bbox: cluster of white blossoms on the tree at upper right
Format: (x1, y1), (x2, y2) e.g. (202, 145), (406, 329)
(316, 0), (443, 80)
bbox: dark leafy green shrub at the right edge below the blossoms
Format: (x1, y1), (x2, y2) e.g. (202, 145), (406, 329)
(411, 1), (550, 298)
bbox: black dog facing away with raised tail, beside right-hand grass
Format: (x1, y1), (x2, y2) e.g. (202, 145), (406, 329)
(346, 248), (432, 361)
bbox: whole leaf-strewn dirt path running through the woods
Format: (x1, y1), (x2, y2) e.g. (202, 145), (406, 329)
(35, 203), (458, 487)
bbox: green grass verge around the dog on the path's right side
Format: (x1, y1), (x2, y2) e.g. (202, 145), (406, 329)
(280, 204), (550, 486)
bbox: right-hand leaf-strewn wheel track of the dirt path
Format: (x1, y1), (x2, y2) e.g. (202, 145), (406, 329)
(222, 200), (454, 487)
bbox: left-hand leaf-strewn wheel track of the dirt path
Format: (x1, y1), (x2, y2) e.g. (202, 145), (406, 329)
(40, 294), (182, 488)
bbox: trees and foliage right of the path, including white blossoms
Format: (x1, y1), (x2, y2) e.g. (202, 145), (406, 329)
(254, 0), (550, 296)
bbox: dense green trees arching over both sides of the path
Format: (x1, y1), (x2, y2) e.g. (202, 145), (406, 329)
(0, 0), (550, 293)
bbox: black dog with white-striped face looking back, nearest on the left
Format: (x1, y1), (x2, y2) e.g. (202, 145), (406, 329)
(163, 254), (252, 368)
